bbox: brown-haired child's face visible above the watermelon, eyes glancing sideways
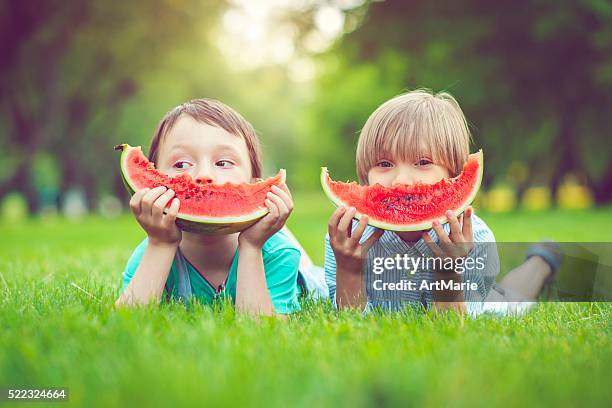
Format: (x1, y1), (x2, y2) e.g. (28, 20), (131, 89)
(157, 115), (251, 184)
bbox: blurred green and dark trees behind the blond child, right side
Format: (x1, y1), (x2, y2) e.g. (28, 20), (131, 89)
(303, 0), (612, 202)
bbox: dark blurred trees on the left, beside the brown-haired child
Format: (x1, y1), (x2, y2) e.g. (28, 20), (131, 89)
(0, 0), (222, 212)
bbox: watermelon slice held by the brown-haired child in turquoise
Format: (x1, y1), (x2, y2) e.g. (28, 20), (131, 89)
(115, 144), (285, 234)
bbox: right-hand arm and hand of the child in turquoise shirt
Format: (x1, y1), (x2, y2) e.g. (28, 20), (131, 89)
(236, 184), (293, 316)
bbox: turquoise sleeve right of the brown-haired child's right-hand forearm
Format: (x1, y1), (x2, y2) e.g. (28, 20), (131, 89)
(264, 247), (301, 314)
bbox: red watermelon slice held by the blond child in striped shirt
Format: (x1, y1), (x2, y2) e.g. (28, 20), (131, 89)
(321, 150), (483, 231)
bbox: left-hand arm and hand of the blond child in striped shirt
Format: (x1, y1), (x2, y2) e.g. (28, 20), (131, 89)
(328, 207), (384, 309)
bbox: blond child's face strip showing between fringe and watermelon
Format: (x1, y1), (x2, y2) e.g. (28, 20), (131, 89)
(368, 156), (450, 187)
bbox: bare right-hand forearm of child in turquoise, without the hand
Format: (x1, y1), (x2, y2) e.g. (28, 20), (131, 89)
(236, 244), (275, 316)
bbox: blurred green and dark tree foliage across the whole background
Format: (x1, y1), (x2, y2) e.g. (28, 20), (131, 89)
(0, 0), (612, 212)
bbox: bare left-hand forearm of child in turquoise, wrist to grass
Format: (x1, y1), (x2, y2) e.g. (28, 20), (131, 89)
(115, 244), (176, 306)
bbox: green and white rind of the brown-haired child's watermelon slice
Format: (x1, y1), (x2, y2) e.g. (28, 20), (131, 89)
(115, 144), (286, 234)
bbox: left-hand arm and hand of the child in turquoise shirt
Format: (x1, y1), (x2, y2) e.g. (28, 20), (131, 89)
(115, 187), (182, 306)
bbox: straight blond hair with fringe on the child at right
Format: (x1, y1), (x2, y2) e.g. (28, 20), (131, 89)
(356, 89), (470, 184)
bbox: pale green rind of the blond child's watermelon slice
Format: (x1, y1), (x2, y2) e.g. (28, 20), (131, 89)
(321, 149), (484, 232)
